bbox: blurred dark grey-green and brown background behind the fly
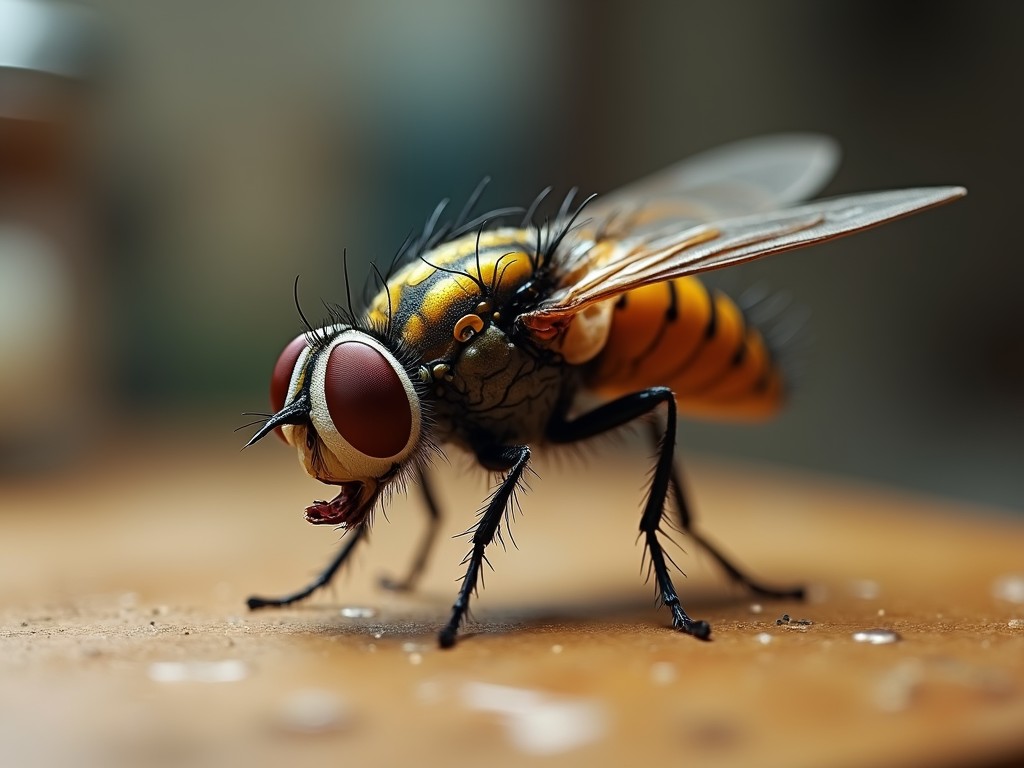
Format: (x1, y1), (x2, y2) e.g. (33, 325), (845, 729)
(0, 0), (1024, 513)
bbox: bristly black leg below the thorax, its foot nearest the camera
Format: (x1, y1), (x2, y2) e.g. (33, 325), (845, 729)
(437, 445), (529, 648)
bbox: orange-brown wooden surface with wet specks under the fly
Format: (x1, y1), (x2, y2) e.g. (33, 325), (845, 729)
(0, 429), (1024, 766)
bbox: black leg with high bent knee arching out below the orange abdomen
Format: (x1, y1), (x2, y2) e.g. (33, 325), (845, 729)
(547, 387), (711, 640)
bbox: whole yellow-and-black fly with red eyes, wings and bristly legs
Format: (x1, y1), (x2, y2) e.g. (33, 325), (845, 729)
(243, 135), (964, 647)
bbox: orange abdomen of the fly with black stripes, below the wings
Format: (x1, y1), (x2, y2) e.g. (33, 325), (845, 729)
(586, 278), (783, 420)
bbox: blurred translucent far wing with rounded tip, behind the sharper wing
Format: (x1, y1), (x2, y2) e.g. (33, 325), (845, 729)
(586, 133), (840, 233)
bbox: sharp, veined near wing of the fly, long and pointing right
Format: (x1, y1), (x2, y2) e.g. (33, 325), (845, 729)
(521, 186), (967, 339)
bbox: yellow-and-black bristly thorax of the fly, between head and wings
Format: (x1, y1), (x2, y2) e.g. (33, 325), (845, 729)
(368, 228), (575, 449)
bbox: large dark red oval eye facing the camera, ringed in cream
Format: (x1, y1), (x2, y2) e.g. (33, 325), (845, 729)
(324, 341), (413, 459)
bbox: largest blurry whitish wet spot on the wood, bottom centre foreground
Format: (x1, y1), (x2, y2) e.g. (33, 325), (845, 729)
(462, 683), (607, 755)
